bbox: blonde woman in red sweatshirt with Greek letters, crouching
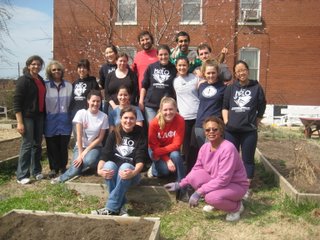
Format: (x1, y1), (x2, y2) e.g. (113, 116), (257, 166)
(148, 97), (185, 181)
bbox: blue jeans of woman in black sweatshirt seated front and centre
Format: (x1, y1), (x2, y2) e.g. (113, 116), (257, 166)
(104, 161), (140, 212)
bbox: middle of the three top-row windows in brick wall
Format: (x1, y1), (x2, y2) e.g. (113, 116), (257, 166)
(181, 0), (202, 24)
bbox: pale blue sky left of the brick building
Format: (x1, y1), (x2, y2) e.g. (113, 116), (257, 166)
(0, 0), (53, 79)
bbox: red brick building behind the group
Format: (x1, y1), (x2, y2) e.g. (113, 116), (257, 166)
(53, 0), (320, 105)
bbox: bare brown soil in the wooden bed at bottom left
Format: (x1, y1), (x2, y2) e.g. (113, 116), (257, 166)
(0, 212), (154, 240)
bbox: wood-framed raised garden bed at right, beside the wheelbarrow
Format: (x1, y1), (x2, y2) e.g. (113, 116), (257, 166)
(256, 135), (320, 202)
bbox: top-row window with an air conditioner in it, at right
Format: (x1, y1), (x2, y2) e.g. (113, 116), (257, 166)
(238, 0), (262, 25)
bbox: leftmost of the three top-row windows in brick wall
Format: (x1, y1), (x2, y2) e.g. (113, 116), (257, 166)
(117, 0), (137, 25)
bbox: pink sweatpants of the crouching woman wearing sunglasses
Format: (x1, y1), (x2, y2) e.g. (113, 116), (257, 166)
(188, 169), (248, 212)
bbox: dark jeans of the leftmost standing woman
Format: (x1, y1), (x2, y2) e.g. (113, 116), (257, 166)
(16, 114), (44, 180)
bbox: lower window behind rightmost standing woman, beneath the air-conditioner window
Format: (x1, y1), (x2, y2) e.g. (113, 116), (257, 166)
(239, 48), (260, 81)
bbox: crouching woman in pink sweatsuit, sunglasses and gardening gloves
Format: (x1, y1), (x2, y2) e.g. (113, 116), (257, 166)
(165, 117), (249, 221)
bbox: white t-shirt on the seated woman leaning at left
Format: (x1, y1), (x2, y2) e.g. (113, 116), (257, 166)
(72, 109), (109, 148)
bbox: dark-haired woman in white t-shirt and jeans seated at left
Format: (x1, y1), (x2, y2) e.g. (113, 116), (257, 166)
(51, 90), (109, 184)
